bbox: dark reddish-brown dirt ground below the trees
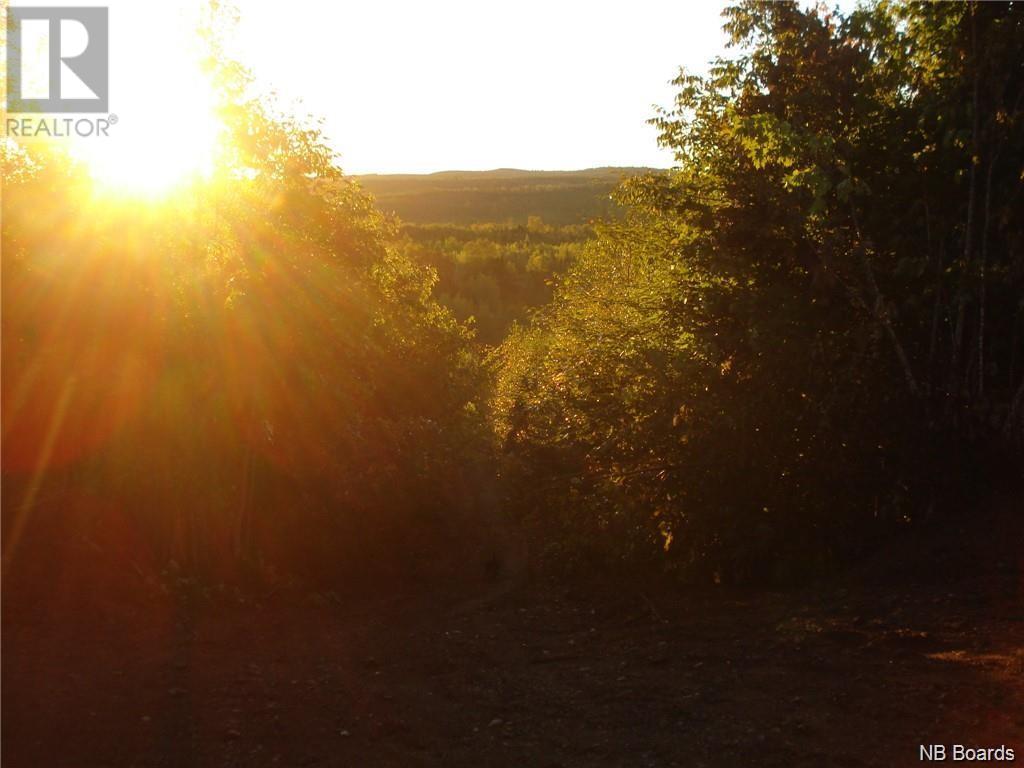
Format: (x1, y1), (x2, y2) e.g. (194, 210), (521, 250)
(2, 528), (1024, 768)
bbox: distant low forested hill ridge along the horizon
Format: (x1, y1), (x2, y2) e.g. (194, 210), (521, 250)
(354, 168), (655, 226)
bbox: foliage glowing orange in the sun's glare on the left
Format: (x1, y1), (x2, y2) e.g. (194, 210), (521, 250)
(3, 54), (480, 570)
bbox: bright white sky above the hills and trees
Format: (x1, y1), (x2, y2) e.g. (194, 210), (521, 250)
(13, 0), (725, 175)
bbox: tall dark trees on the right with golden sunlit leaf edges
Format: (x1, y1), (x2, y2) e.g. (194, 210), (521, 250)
(494, 2), (1024, 581)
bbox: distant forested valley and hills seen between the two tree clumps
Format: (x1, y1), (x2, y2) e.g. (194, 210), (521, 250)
(355, 173), (645, 345)
